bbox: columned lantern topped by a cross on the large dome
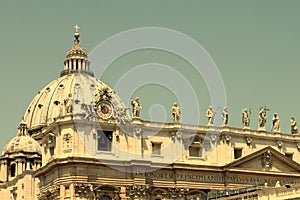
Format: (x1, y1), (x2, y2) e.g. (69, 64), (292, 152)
(60, 24), (94, 76)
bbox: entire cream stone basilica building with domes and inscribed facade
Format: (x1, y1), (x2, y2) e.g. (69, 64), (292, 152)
(0, 27), (300, 200)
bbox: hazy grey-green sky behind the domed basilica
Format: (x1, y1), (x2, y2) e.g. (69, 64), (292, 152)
(0, 0), (300, 149)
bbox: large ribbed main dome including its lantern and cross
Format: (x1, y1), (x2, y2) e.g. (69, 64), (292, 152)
(24, 25), (128, 129)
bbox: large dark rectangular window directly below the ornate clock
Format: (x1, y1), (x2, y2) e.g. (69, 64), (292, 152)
(97, 130), (113, 151)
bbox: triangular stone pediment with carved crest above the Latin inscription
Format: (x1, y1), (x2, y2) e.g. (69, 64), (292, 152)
(225, 146), (300, 173)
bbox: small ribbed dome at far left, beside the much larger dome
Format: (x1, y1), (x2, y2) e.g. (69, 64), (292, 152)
(2, 135), (42, 155)
